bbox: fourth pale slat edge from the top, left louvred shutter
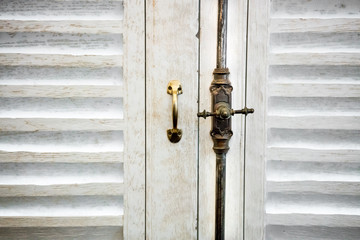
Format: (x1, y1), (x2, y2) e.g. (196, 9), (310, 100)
(0, 118), (125, 131)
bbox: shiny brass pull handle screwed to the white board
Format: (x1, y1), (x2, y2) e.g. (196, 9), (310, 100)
(167, 80), (182, 143)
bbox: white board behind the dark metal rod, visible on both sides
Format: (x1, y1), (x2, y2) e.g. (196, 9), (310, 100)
(199, 0), (247, 239)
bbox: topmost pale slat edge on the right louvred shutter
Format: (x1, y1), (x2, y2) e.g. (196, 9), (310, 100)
(270, 18), (360, 33)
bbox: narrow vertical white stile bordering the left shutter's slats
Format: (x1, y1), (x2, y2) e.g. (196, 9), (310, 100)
(124, 0), (147, 240)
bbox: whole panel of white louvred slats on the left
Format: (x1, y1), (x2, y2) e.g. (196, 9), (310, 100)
(0, 0), (144, 239)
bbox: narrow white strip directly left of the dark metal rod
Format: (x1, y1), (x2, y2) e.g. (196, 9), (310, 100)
(198, 1), (215, 239)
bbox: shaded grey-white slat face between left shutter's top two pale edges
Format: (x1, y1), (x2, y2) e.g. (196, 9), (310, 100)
(0, 32), (123, 56)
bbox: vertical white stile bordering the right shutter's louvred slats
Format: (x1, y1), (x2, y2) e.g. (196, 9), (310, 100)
(244, 0), (270, 239)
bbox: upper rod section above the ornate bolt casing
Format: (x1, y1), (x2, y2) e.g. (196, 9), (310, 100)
(216, 0), (228, 68)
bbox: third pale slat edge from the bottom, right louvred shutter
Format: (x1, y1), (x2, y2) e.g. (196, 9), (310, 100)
(267, 147), (360, 163)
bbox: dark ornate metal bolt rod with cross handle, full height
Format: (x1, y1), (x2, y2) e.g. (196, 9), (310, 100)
(197, 0), (254, 237)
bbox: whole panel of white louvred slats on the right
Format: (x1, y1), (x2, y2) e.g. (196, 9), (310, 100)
(265, 0), (360, 240)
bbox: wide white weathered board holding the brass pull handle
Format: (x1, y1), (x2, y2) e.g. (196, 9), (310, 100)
(145, 0), (199, 239)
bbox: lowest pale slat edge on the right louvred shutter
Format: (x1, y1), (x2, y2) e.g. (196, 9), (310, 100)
(266, 213), (360, 227)
